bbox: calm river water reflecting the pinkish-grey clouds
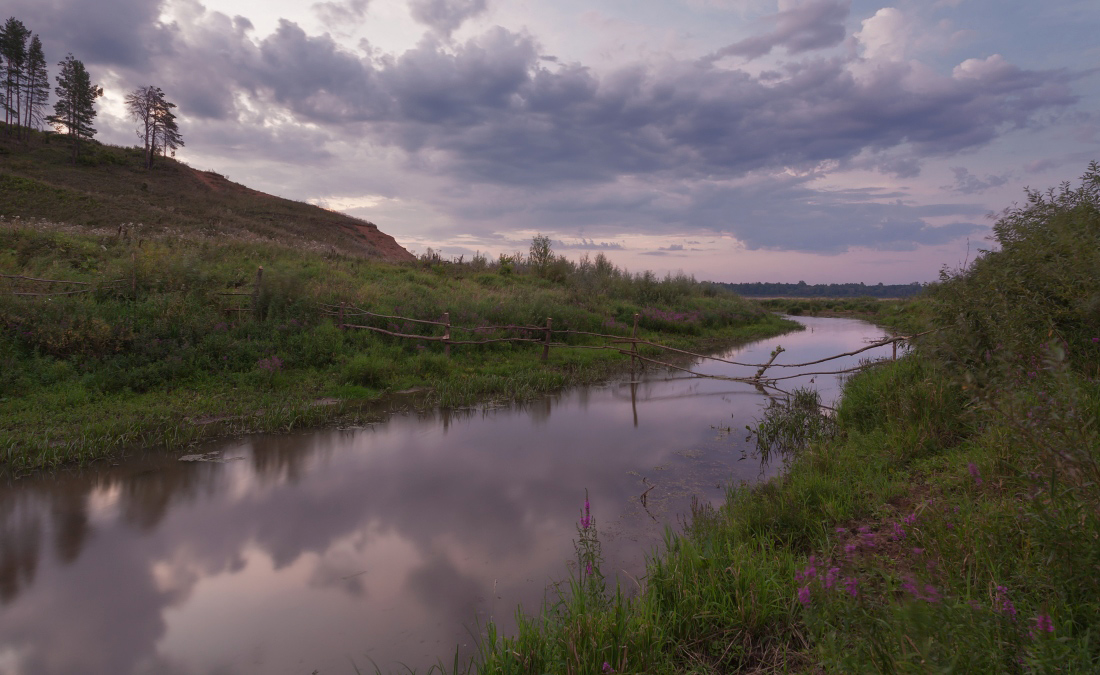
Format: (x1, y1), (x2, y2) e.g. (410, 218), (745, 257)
(0, 318), (890, 675)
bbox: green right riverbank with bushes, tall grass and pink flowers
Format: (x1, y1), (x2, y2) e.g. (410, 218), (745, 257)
(479, 164), (1100, 673)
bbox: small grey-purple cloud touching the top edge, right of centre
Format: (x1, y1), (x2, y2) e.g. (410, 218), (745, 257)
(710, 0), (851, 59)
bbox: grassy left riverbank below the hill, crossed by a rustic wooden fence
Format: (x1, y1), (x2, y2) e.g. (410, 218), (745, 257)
(0, 222), (796, 472)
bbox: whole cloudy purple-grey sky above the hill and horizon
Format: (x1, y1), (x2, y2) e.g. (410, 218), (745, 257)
(4, 0), (1100, 284)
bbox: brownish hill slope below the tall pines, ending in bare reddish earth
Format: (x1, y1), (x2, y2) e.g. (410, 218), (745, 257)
(0, 133), (414, 262)
